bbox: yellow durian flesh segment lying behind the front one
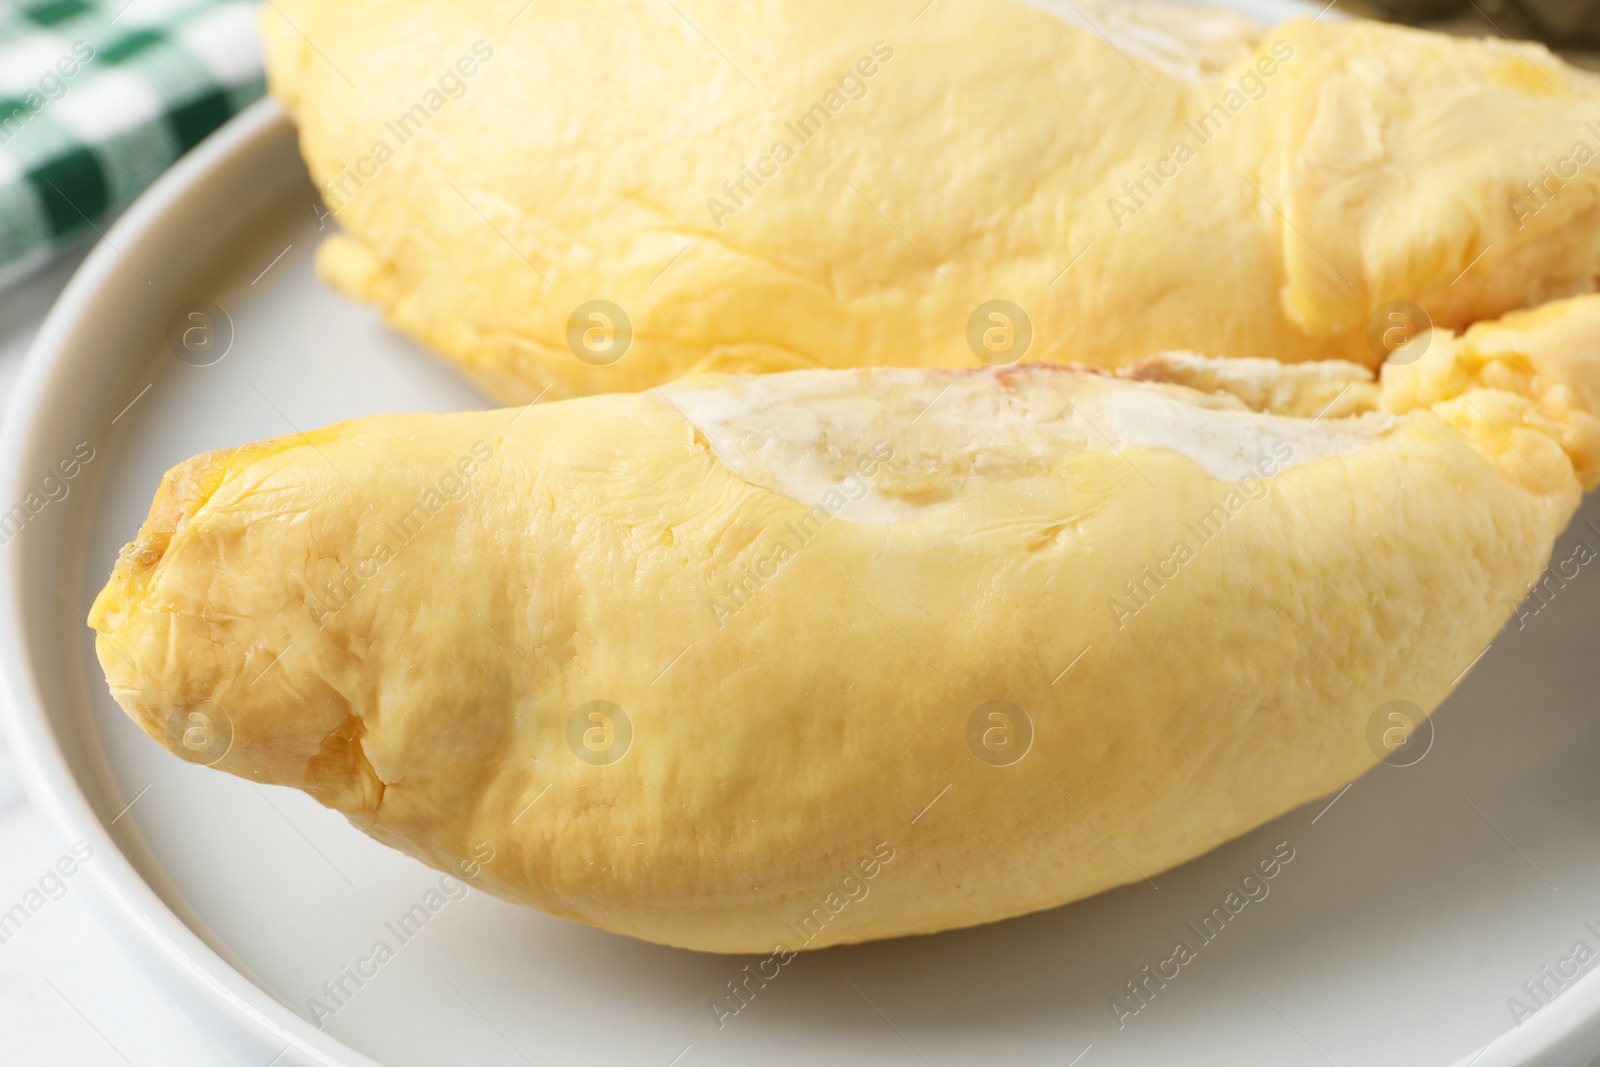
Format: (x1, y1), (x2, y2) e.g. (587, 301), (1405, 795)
(262, 0), (1600, 403)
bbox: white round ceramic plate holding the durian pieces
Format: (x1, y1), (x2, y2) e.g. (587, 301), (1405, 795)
(9, 10), (1600, 1067)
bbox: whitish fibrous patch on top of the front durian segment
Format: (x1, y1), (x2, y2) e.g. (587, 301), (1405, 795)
(658, 357), (1395, 523)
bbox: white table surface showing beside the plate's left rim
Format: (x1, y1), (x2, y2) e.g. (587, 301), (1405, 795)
(0, 256), (235, 1067)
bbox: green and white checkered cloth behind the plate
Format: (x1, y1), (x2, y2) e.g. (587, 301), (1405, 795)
(0, 0), (262, 288)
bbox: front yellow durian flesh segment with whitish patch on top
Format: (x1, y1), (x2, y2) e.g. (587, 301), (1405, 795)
(91, 298), (1600, 952)
